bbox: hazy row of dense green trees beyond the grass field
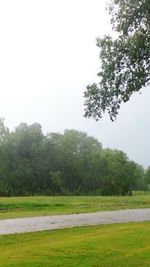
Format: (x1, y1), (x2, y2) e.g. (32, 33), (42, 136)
(0, 119), (150, 196)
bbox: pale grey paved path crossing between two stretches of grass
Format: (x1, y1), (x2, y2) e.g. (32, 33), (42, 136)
(0, 209), (150, 235)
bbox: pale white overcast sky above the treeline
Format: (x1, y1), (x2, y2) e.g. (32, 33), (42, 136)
(0, 0), (150, 167)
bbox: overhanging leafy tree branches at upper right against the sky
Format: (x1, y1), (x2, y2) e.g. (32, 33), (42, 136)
(84, 0), (150, 120)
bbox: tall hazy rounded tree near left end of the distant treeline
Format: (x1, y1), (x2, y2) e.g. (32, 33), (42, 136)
(5, 123), (43, 195)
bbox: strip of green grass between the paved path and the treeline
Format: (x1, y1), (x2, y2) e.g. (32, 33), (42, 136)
(0, 195), (150, 219)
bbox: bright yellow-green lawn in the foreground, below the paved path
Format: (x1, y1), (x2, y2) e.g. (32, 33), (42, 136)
(0, 222), (150, 267)
